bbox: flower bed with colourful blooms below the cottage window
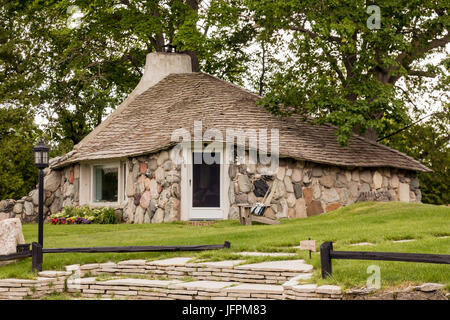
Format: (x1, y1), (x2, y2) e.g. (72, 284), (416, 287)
(50, 206), (117, 224)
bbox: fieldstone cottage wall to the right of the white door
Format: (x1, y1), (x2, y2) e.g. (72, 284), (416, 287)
(229, 159), (421, 219)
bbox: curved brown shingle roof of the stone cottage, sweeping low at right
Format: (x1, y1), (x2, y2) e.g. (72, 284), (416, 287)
(53, 73), (430, 171)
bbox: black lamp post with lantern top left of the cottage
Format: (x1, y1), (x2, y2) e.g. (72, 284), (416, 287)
(33, 140), (50, 246)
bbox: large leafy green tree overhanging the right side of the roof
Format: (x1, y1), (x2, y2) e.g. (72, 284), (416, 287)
(245, 0), (450, 144)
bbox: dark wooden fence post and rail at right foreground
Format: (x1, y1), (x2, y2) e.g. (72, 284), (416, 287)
(320, 242), (450, 278)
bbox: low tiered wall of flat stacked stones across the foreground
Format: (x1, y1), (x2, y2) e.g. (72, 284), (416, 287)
(0, 257), (444, 300)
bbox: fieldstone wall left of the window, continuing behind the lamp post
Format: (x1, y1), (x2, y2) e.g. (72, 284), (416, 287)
(0, 160), (80, 222)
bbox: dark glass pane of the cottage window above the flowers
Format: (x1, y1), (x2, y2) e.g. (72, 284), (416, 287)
(94, 166), (119, 202)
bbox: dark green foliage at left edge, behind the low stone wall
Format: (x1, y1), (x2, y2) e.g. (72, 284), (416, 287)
(0, 107), (39, 199)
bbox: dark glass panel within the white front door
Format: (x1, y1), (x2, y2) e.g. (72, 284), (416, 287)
(192, 152), (220, 208)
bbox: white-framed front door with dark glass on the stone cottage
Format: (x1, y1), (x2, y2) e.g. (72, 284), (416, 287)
(188, 143), (224, 220)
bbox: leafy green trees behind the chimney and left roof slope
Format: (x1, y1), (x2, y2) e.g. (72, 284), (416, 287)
(0, 0), (253, 151)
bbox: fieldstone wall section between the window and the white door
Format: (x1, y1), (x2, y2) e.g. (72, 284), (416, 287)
(123, 151), (181, 223)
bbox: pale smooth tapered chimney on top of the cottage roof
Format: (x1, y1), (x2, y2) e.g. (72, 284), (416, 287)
(133, 52), (192, 94)
